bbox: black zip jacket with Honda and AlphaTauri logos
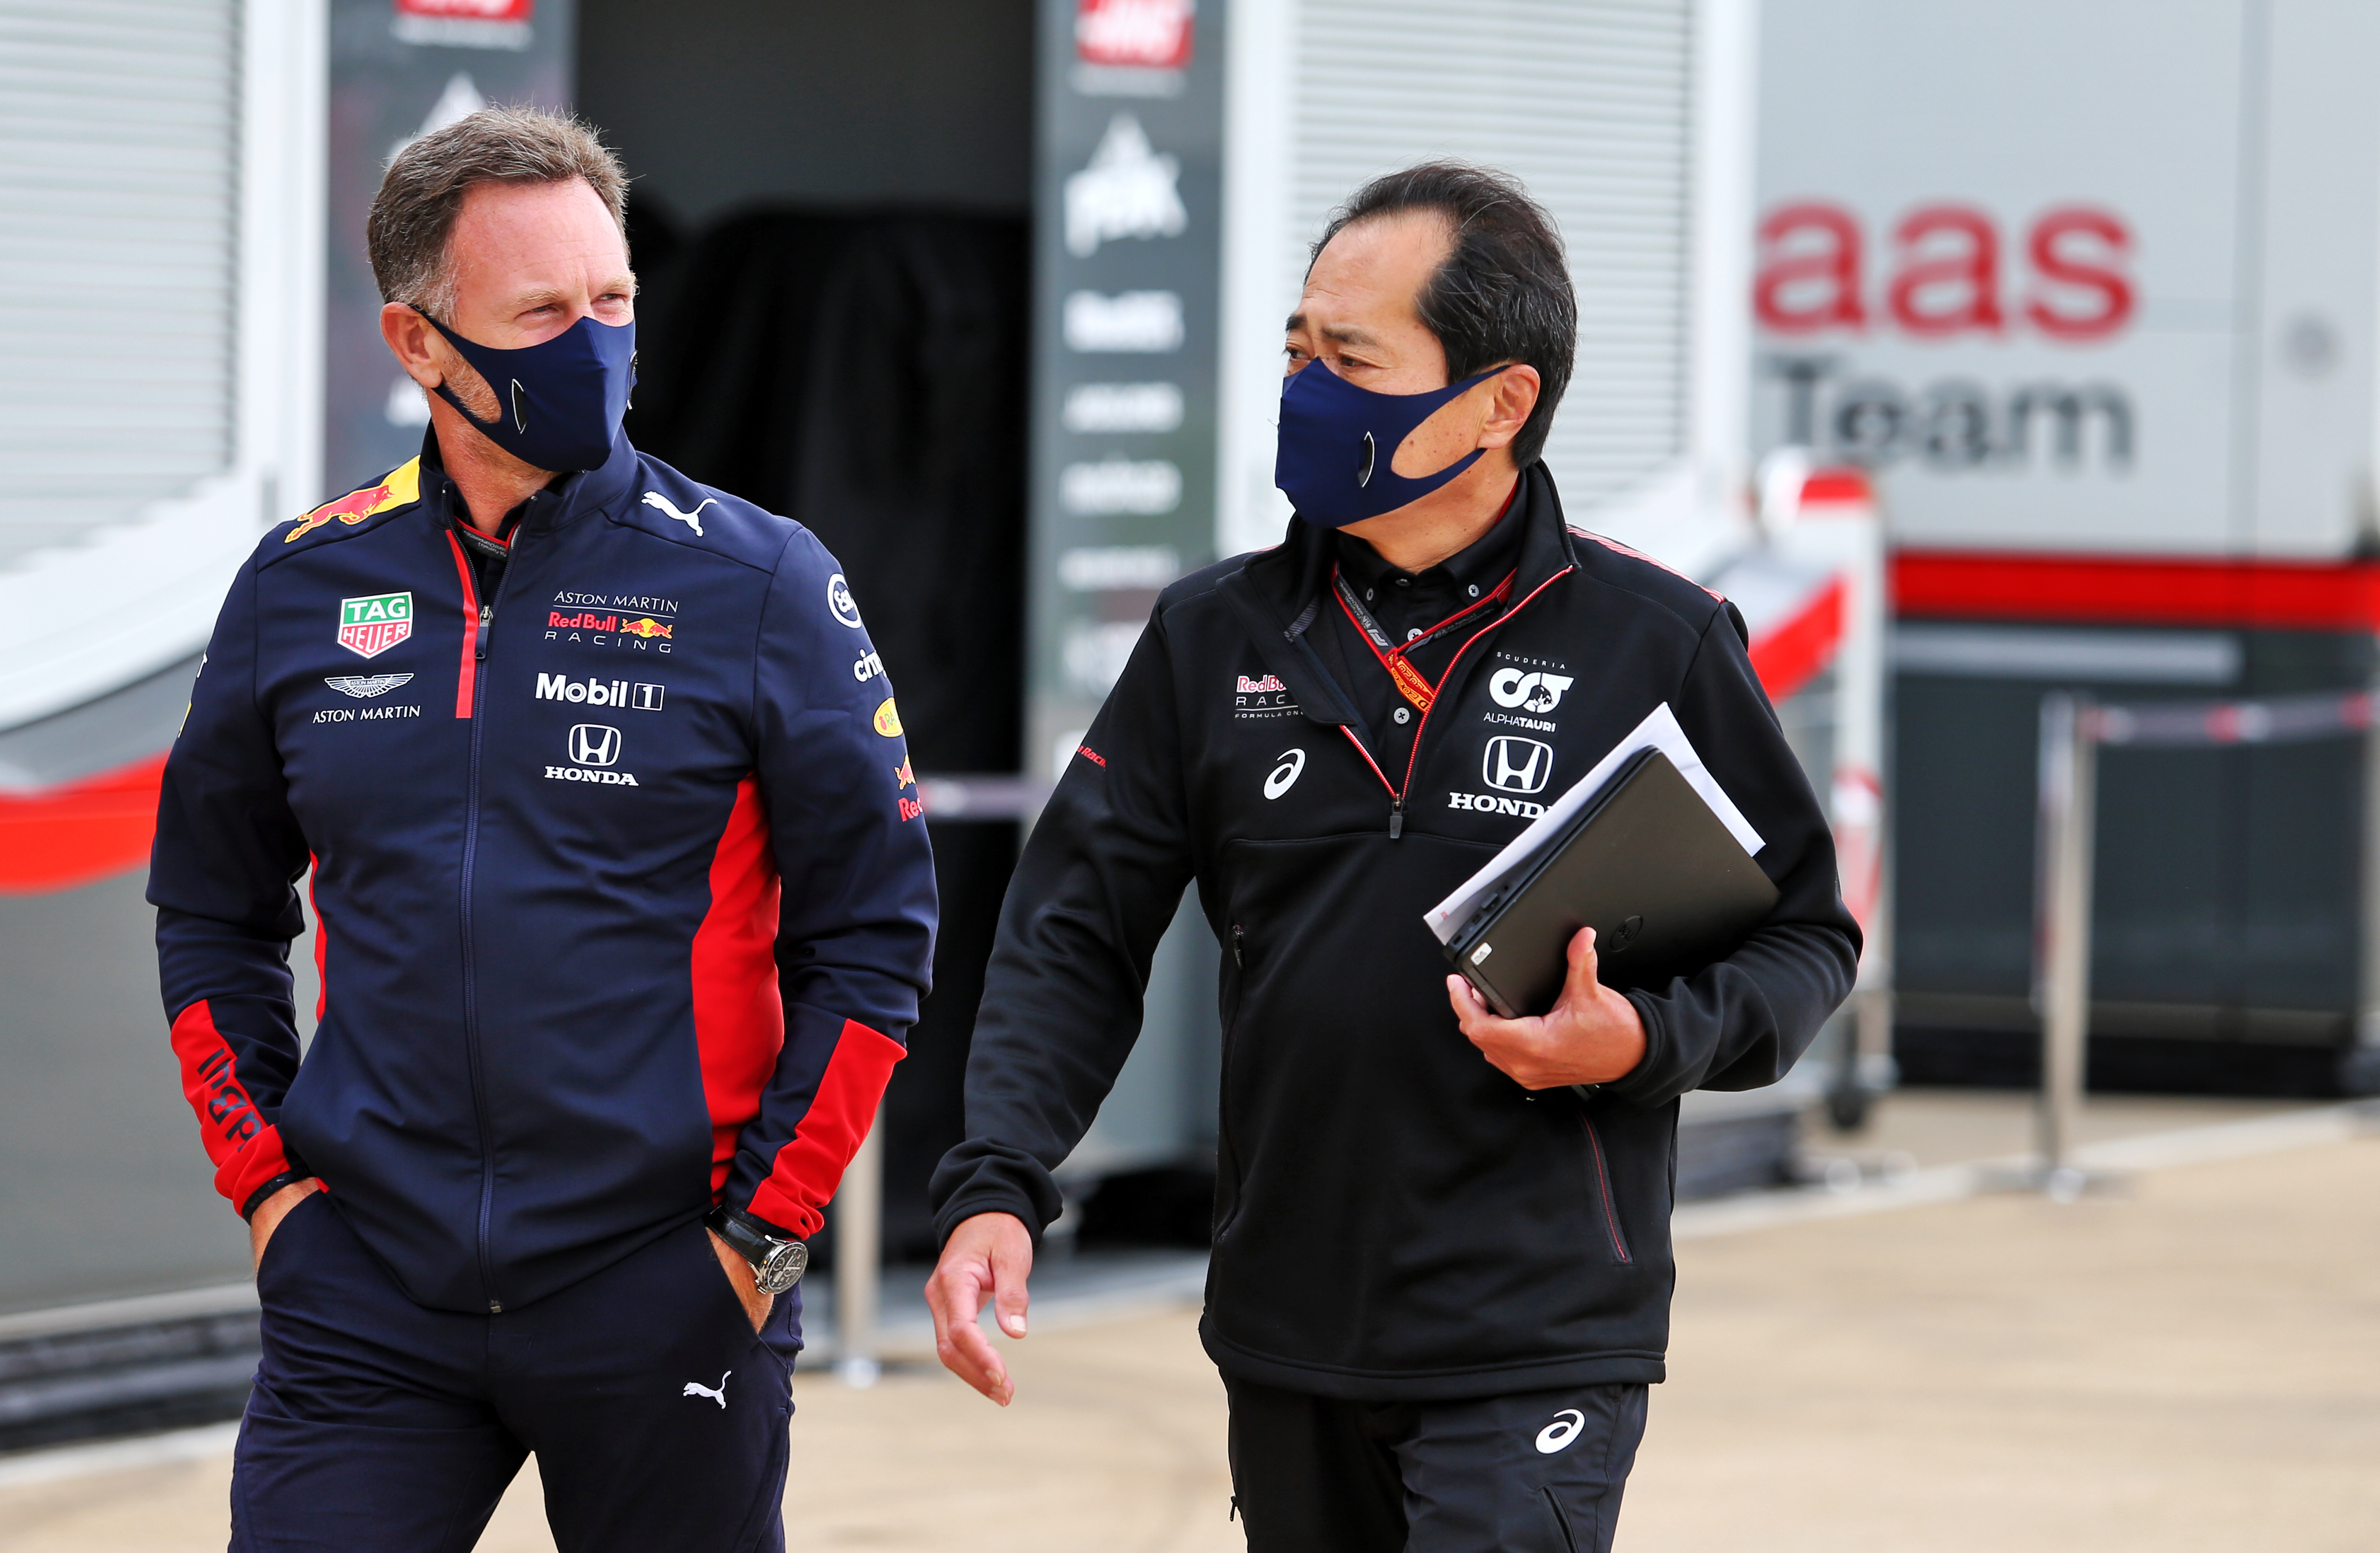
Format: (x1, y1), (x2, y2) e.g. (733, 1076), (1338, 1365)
(933, 466), (1859, 1398)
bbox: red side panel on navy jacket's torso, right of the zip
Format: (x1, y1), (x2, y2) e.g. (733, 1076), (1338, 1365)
(693, 775), (785, 1194)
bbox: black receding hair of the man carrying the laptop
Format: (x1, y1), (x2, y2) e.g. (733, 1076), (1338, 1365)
(1307, 162), (1578, 469)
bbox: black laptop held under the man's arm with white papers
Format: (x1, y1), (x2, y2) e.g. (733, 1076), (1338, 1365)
(1445, 749), (1778, 1018)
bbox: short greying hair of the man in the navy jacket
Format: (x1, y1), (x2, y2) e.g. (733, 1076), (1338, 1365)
(364, 107), (628, 321)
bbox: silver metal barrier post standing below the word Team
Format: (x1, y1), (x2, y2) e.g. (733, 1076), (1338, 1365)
(2035, 692), (2099, 1201)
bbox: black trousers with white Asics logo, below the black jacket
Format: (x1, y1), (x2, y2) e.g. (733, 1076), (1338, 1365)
(1223, 1375), (1645, 1553)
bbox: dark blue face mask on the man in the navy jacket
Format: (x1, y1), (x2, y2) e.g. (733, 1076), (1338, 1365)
(421, 314), (636, 473)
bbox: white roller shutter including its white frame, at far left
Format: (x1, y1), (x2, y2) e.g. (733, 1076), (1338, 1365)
(0, 0), (326, 730)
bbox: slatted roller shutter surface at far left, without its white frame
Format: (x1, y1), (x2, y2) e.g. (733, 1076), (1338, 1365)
(0, 0), (240, 566)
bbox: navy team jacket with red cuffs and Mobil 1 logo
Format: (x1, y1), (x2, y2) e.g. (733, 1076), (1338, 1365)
(150, 438), (935, 1313)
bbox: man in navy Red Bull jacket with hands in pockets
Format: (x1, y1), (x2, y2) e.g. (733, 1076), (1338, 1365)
(150, 109), (935, 1551)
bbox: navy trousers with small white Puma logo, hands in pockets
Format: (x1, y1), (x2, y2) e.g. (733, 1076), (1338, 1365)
(231, 1192), (802, 1553)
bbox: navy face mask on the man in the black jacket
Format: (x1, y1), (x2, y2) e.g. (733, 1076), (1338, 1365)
(1273, 361), (1504, 528)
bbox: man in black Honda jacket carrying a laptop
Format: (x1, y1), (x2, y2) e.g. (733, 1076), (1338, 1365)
(928, 164), (1859, 1553)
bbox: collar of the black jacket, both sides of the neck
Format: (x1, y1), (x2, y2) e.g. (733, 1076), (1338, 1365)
(1216, 464), (1578, 728)
